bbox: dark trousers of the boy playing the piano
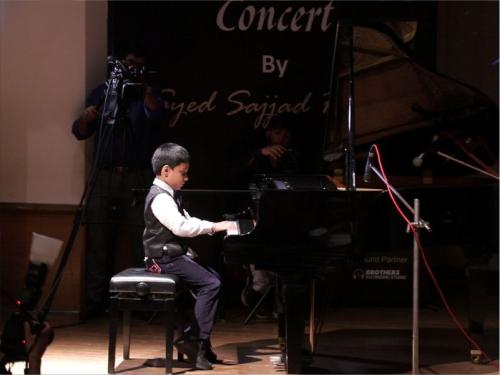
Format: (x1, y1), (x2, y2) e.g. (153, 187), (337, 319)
(157, 255), (222, 340)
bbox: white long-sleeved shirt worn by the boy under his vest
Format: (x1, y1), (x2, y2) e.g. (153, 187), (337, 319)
(151, 178), (214, 237)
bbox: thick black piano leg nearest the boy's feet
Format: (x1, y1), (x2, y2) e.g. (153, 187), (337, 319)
(283, 283), (307, 374)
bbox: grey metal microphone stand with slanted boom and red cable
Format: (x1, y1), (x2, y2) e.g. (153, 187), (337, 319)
(369, 163), (431, 374)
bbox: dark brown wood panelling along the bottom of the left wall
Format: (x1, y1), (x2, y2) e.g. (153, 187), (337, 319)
(0, 204), (85, 321)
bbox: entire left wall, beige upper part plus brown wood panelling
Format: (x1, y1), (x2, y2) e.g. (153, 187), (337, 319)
(0, 0), (107, 313)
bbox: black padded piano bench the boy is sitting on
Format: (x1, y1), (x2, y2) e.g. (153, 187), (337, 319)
(108, 268), (180, 374)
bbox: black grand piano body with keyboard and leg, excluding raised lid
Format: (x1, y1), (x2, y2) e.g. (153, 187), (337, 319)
(223, 175), (364, 373)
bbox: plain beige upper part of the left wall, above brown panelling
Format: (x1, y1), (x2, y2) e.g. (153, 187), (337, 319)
(0, 0), (107, 204)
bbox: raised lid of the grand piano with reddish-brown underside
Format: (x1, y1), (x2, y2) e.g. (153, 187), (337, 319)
(326, 21), (493, 153)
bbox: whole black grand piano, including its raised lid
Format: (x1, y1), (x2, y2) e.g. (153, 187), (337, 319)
(218, 15), (498, 373)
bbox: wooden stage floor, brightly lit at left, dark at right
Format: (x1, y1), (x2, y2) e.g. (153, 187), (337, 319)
(4, 303), (498, 375)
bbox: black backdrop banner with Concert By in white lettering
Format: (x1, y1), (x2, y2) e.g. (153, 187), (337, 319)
(109, 0), (337, 189)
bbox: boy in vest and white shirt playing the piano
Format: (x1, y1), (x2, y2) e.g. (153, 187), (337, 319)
(143, 143), (236, 370)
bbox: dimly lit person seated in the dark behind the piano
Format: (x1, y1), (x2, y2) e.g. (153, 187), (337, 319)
(241, 122), (298, 318)
